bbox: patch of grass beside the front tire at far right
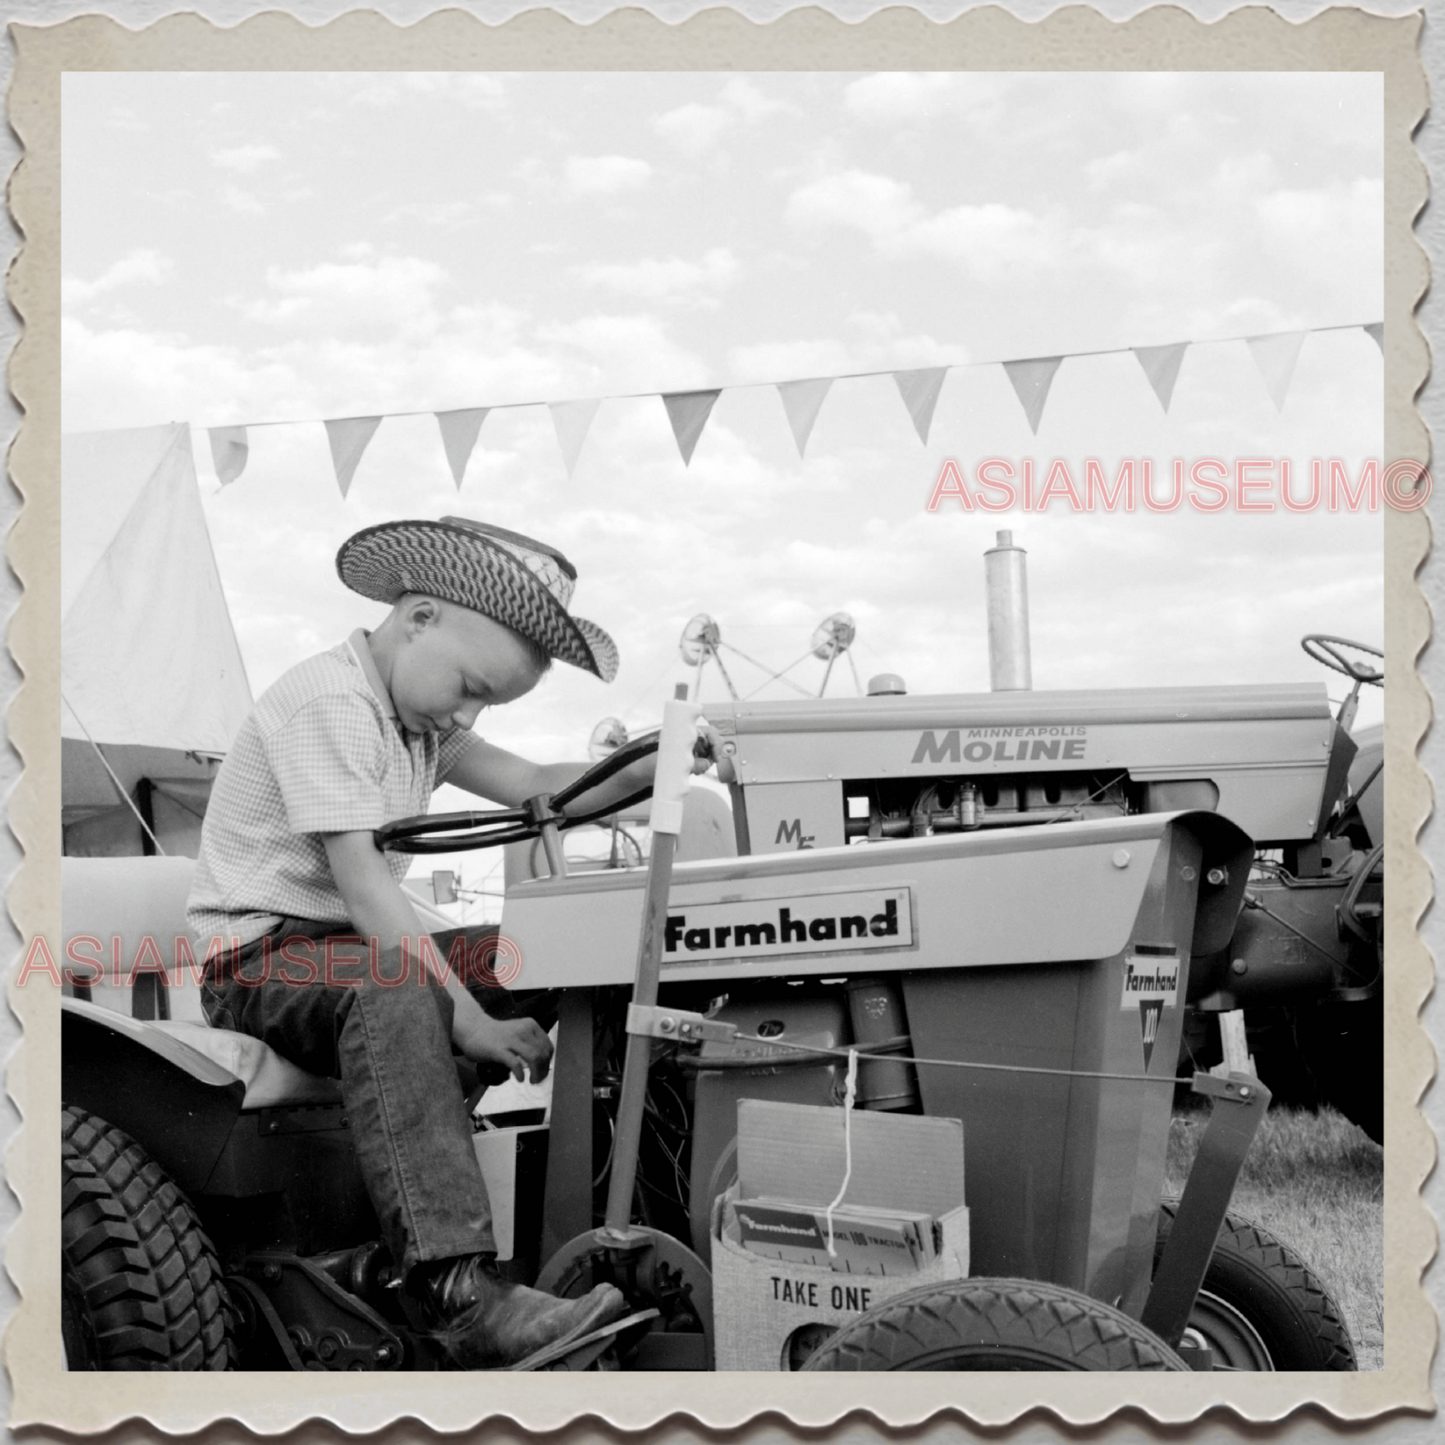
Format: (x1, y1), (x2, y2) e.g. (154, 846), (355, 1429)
(1165, 1108), (1384, 1370)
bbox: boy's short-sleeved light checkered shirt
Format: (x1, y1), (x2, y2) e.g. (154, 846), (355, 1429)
(186, 633), (478, 949)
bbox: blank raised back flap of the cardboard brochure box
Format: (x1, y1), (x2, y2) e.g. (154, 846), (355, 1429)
(737, 1098), (964, 1218)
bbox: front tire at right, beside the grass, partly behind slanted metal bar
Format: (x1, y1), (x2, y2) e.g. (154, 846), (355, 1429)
(1155, 1199), (1357, 1370)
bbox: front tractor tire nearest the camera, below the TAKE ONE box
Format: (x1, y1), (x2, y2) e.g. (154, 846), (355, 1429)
(802, 1279), (1189, 1370)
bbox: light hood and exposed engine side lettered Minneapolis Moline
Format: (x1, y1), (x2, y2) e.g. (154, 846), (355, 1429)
(707, 683), (1355, 855)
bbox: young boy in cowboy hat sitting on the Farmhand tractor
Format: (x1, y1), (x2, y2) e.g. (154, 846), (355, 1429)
(188, 517), (705, 1368)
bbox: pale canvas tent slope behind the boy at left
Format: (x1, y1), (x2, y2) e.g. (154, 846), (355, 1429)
(61, 423), (251, 753)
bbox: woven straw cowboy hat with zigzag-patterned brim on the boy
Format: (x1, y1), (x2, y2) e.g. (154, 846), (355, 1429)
(337, 517), (617, 682)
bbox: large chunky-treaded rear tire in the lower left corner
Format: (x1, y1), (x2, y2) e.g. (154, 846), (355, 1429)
(61, 1107), (234, 1370)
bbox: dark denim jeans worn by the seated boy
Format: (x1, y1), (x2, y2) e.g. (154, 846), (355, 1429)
(201, 918), (496, 1269)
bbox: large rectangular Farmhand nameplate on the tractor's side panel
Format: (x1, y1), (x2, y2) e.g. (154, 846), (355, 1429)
(662, 889), (913, 964)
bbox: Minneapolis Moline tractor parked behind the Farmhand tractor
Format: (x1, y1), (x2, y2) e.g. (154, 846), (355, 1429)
(705, 678), (1383, 1134)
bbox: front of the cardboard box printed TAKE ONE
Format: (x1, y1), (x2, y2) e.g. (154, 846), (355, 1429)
(712, 1186), (968, 1370)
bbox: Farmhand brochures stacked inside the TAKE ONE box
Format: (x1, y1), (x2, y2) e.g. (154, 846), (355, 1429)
(730, 1199), (942, 1274)
